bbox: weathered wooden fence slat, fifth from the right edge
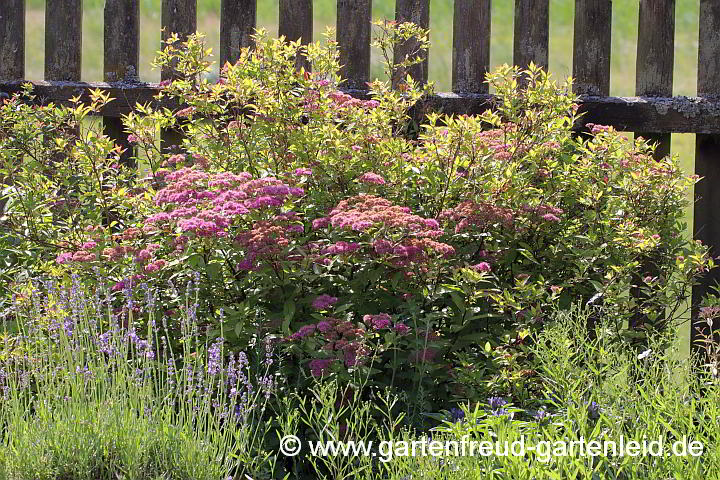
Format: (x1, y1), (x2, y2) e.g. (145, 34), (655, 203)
(452, 0), (491, 93)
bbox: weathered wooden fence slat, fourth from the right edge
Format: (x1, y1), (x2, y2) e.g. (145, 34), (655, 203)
(513, 0), (550, 69)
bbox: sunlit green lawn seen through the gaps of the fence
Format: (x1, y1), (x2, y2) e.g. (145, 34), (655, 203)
(26, 0), (699, 352)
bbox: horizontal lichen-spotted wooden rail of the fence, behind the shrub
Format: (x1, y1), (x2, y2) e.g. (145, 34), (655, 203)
(0, 81), (720, 134)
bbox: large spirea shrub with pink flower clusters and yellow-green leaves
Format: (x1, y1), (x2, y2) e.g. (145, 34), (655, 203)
(0, 24), (712, 409)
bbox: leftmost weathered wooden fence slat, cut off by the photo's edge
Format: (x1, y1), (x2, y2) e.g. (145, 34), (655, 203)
(0, 0), (25, 80)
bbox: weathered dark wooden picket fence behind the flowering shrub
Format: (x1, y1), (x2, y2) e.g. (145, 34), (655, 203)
(0, 0), (720, 356)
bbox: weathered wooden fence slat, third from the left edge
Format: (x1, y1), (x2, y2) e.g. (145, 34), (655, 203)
(103, 0), (140, 165)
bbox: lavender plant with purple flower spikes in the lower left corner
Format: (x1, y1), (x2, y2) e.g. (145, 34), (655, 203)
(0, 276), (277, 480)
